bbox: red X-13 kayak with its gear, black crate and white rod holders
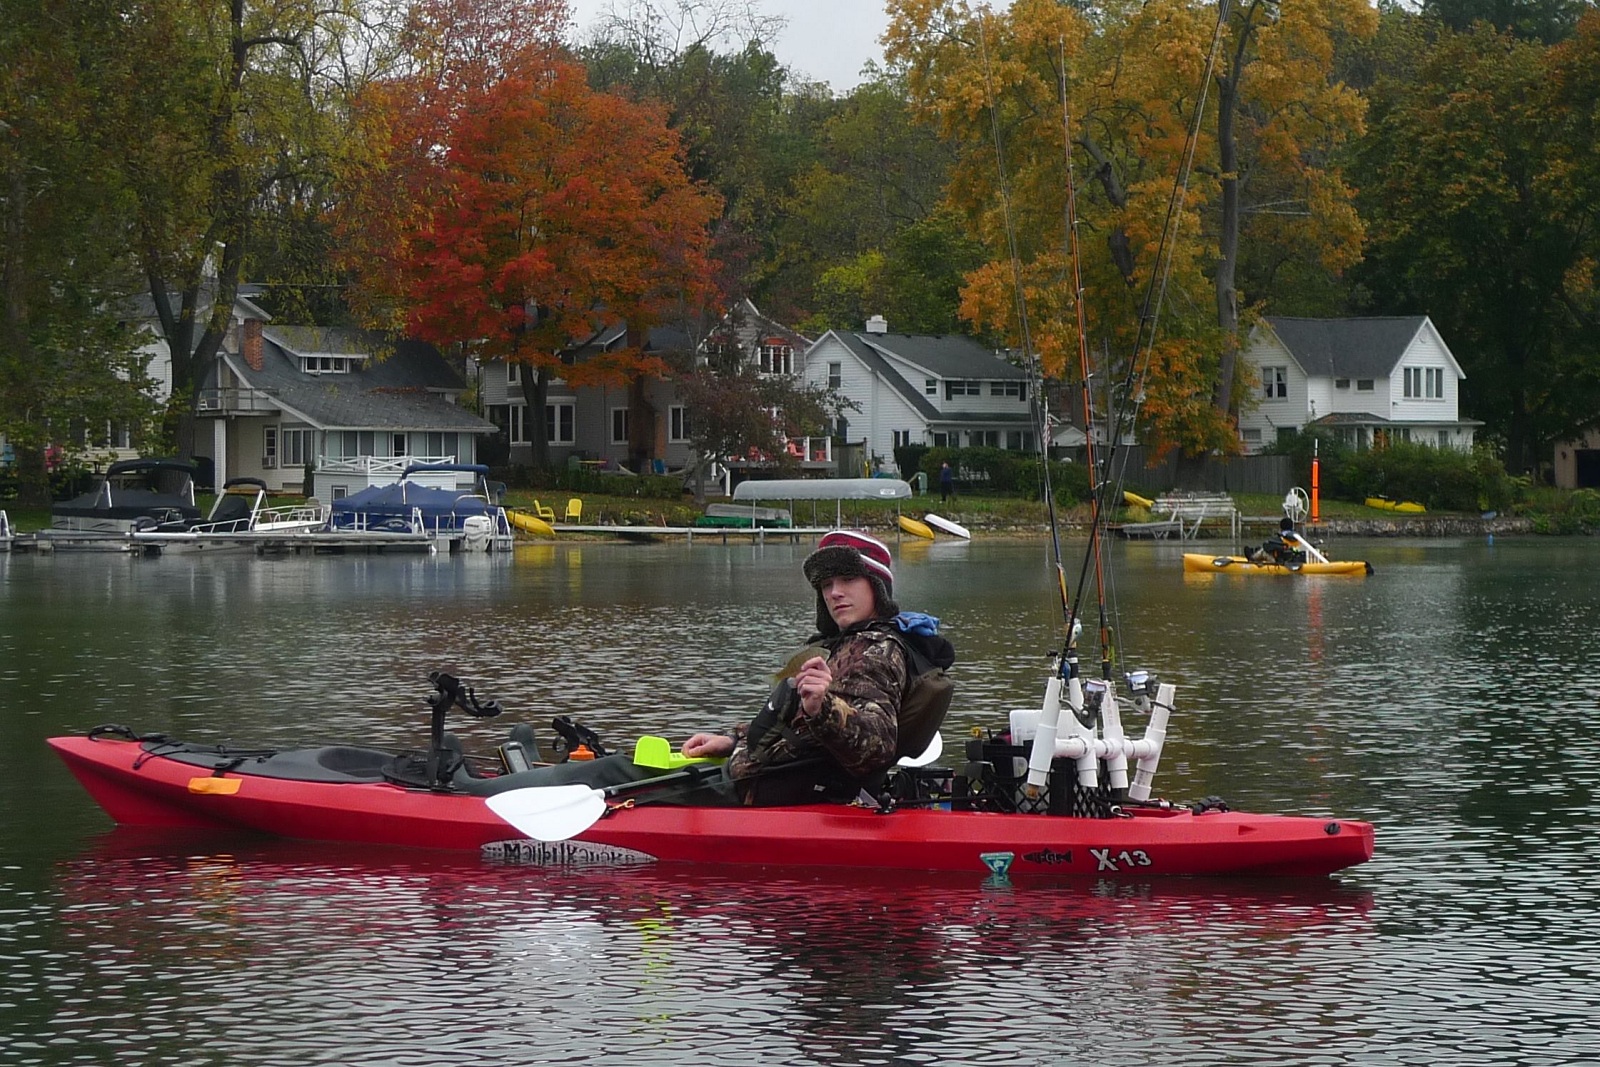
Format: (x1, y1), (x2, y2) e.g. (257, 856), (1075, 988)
(50, 672), (1373, 878)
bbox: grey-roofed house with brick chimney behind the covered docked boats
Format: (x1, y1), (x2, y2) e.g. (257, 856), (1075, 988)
(197, 301), (496, 502)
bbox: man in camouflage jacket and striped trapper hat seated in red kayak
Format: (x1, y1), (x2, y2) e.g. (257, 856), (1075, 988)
(493, 530), (955, 805)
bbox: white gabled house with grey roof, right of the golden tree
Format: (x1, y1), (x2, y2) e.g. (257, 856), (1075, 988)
(1238, 315), (1483, 453)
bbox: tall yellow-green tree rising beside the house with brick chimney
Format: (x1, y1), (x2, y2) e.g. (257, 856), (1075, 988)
(96, 0), (378, 453)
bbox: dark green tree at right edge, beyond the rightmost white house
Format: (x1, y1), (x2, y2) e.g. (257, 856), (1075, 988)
(1360, 21), (1600, 470)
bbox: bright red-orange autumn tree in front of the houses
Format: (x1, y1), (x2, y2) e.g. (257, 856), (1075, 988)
(341, 0), (720, 466)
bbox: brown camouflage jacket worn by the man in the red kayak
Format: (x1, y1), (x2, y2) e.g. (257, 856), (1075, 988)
(728, 619), (909, 805)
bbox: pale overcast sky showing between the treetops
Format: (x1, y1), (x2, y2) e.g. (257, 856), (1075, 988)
(568, 0), (890, 94)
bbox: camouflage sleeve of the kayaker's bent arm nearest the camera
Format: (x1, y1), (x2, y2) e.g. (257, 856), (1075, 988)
(805, 632), (907, 777)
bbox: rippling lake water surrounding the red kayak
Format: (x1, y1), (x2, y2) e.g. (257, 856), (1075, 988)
(0, 539), (1600, 1067)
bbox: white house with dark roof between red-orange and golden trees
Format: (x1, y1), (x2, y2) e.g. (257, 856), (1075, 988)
(805, 315), (1035, 469)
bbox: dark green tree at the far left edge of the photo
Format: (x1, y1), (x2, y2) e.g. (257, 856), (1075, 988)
(0, 0), (154, 506)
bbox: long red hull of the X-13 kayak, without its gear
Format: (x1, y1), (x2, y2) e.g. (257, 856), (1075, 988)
(50, 737), (1373, 877)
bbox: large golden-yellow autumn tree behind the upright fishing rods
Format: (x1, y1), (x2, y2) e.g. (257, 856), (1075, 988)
(890, 0), (1373, 454)
